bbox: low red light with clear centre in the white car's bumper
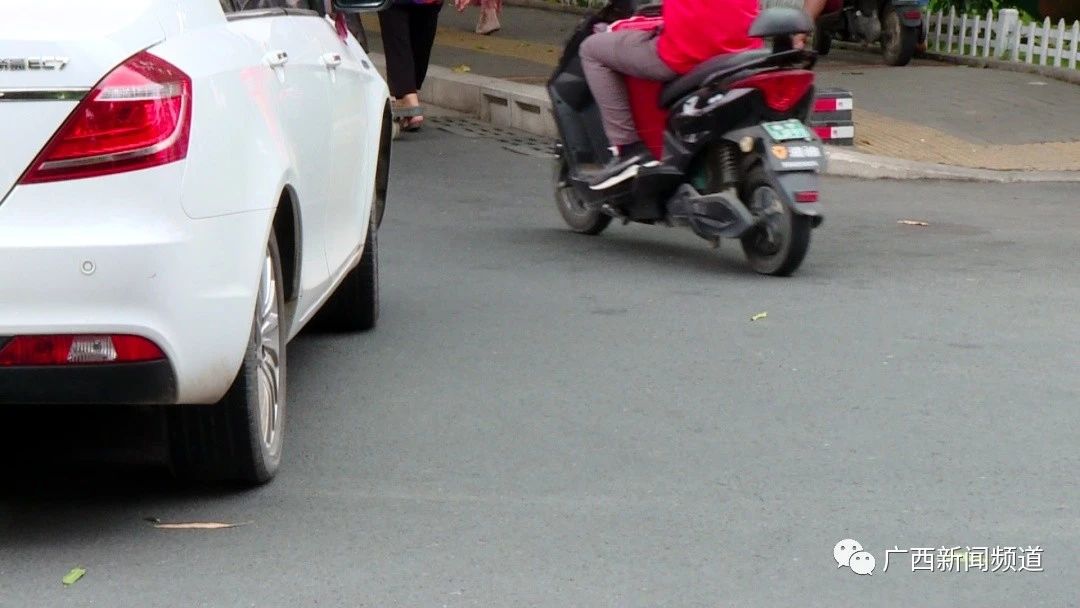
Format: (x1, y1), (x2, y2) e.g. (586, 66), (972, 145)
(0, 336), (165, 367)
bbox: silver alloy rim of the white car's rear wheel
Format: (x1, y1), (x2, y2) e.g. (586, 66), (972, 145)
(256, 255), (281, 451)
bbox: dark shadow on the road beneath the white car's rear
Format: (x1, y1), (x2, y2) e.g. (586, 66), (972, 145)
(0, 405), (259, 548)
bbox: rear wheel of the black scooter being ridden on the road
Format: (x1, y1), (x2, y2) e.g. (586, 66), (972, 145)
(742, 167), (811, 276)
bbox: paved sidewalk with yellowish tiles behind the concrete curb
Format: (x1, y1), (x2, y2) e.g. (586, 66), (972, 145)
(364, 5), (1080, 172)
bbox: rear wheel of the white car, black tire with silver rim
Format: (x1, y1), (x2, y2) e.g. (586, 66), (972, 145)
(166, 234), (287, 485)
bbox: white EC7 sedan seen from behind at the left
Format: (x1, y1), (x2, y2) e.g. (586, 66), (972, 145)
(0, 0), (391, 483)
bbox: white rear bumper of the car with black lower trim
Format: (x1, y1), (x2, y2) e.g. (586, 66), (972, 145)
(0, 163), (273, 404)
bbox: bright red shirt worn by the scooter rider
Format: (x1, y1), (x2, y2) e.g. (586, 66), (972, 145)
(657, 0), (762, 75)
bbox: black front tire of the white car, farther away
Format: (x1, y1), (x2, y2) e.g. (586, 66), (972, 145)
(315, 210), (379, 332)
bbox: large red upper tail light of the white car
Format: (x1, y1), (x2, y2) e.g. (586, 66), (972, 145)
(21, 51), (191, 184)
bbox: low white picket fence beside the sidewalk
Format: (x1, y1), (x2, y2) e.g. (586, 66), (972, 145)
(924, 9), (1080, 69)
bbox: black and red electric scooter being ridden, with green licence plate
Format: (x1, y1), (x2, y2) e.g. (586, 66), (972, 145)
(548, 0), (826, 275)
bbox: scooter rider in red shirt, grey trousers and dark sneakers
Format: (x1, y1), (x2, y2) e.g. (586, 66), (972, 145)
(580, 0), (764, 190)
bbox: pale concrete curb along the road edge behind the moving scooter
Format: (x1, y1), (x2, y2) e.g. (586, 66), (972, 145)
(370, 53), (1080, 184)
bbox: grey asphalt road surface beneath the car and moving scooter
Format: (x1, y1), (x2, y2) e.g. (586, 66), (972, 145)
(0, 129), (1080, 608)
